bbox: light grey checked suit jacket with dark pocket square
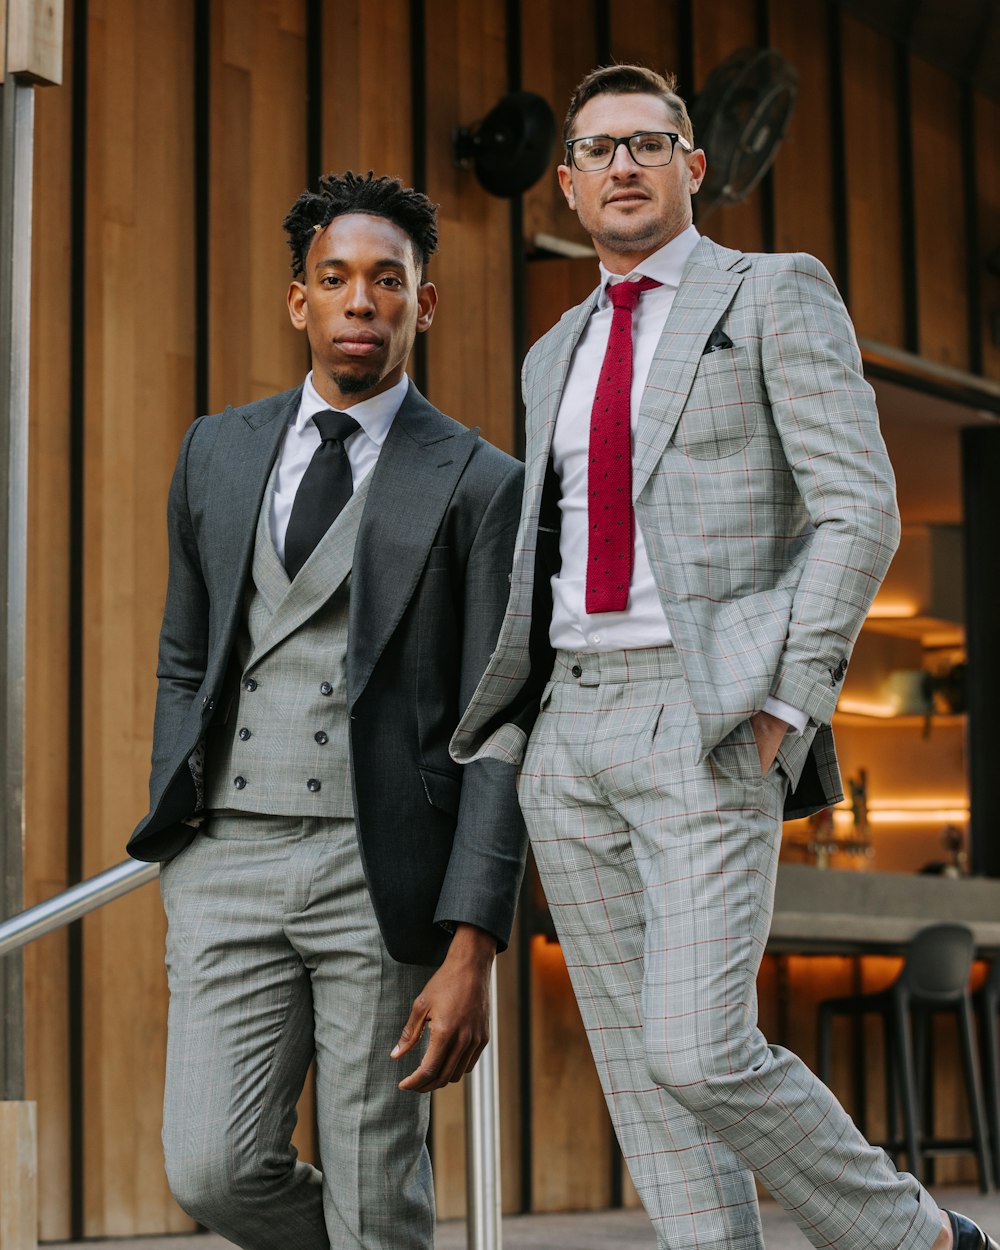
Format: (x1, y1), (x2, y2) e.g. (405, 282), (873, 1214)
(451, 238), (899, 816)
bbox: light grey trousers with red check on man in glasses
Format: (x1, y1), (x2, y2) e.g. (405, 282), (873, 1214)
(519, 646), (941, 1250)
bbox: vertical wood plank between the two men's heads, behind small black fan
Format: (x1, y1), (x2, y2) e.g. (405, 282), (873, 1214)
(425, 0), (514, 451)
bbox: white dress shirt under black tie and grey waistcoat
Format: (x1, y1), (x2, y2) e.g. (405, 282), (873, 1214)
(271, 371), (410, 561)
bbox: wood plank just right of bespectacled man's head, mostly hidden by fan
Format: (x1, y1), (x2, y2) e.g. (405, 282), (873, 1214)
(681, 0), (764, 251)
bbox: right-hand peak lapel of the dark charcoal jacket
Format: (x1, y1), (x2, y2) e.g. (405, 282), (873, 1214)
(348, 383), (479, 706)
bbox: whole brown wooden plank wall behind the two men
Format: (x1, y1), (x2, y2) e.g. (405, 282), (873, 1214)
(19, 0), (1000, 1240)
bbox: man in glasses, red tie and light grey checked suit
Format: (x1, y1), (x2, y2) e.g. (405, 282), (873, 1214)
(453, 66), (996, 1250)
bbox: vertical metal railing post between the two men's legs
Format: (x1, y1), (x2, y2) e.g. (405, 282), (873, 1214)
(465, 964), (503, 1250)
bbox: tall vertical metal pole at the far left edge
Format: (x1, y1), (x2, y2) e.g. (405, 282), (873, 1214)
(0, 75), (35, 1101)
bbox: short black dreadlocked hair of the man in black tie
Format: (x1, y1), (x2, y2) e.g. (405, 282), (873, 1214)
(281, 170), (438, 281)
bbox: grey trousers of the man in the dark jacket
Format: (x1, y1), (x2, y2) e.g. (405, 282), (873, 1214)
(160, 813), (434, 1250)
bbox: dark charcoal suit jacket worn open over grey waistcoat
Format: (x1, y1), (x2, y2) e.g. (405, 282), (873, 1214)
(129, 383), (526, 964)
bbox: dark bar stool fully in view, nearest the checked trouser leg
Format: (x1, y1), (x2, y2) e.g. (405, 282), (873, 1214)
(818, 925), (996, 1194)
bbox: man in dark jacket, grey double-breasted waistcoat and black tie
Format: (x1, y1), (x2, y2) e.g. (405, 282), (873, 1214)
(129, 174), (526, 1250)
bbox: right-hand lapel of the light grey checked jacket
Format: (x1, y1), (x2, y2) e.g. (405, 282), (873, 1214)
(633, 238), (750, 500)
